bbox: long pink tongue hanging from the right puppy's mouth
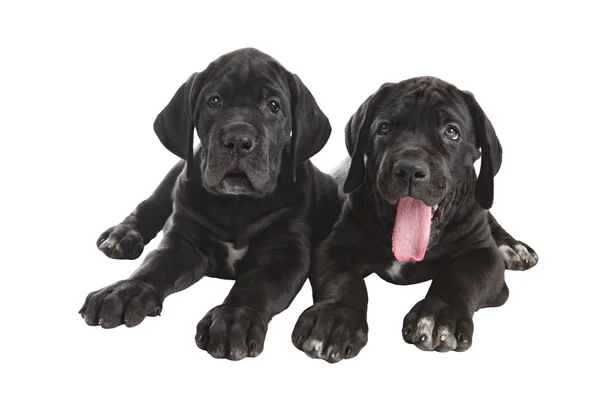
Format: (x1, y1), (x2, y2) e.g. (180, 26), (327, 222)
(392, 197), (431, 261)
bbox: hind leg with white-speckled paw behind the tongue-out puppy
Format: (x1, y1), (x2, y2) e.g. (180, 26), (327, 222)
(488, 212), (539, 271)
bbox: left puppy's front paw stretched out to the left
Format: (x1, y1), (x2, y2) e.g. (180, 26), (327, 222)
(79, 279), (162, 328)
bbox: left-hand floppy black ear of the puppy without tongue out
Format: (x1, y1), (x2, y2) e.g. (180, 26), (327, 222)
(154, 72), (205, 179)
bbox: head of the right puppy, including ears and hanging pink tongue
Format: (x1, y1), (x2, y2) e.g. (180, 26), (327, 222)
(344, 77), (502, 261)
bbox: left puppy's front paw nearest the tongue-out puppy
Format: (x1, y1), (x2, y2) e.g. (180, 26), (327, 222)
(196, 305), (268, 361)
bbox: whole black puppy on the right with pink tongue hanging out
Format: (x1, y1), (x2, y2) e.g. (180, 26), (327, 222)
(292, 77), (537, 362)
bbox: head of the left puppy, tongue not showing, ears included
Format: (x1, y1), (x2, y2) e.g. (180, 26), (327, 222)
(154, 49), (331, 197)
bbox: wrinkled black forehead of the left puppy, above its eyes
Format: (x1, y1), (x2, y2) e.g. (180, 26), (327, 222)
(203, 58), (289, 101)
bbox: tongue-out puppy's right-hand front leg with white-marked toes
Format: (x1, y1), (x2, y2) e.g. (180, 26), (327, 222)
(402, 247), (508, 352)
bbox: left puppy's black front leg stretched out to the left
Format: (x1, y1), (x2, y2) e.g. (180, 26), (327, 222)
(79, 231), (220, 328)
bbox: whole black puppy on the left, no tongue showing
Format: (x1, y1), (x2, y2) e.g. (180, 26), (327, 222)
(80, 49), (341, 360)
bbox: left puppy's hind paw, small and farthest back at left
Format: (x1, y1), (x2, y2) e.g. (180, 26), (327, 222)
(96, 225), (144, 260)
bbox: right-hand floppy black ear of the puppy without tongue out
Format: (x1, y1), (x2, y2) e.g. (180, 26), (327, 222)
(287, 72), (331, 180)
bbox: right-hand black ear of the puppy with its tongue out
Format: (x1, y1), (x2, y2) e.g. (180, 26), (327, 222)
(464, 92), (502, 210)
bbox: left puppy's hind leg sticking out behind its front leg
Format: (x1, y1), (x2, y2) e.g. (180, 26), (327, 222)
(96, 161), (185, 260)
